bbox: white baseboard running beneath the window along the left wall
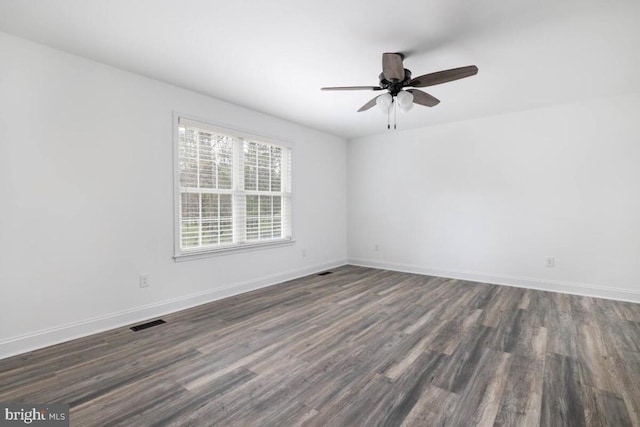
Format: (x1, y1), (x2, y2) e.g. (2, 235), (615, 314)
(0, 260), (347, 359)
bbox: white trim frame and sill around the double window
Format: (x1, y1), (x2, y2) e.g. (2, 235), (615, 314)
(173, 111), (295, 262)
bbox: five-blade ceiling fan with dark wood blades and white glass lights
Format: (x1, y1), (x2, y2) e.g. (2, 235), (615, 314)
(321, 53), (478, 128)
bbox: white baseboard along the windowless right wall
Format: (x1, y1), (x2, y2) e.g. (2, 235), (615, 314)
(349, 258), (640, 303)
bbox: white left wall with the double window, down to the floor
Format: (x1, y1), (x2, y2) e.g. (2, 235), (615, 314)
(0, 33), (346, 358)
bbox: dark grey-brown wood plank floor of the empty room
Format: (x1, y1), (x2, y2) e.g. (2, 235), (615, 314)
(0, 266), (640, 427)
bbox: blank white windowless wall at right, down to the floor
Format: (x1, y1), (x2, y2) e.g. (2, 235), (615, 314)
(347, 94), (640, 302)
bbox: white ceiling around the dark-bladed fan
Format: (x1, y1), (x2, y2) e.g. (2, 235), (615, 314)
(0, 0), (640, 138)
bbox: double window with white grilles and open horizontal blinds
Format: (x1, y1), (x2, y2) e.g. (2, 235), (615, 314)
(175, 117), (292, 257)
